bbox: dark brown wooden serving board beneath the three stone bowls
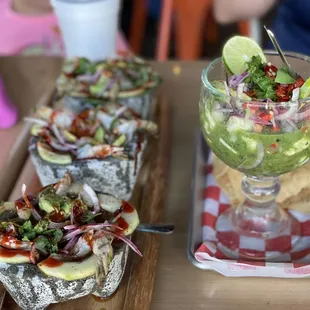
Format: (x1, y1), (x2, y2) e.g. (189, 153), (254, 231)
(2, 96), (171, 310)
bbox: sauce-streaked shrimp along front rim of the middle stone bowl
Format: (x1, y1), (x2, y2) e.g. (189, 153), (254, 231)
(77, 144), (125, 159)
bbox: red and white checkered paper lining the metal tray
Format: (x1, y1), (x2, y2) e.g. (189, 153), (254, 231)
(195, 159), (310, 278)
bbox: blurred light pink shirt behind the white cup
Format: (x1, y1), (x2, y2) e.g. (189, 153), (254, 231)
(0, 0), (128, 56)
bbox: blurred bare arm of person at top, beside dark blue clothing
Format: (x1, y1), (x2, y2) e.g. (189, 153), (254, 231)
(214, 0), (277, 24)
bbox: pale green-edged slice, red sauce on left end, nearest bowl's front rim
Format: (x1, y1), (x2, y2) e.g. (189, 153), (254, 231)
(37, 254), (97, 281)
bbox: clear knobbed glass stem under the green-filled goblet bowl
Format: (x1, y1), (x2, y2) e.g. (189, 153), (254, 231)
(232, 176), (288, 237)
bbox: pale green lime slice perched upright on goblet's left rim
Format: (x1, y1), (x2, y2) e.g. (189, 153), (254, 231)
(222, 36), (267, 74)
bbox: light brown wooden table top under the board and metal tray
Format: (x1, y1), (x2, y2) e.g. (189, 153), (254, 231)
(0, 58), (310, 310)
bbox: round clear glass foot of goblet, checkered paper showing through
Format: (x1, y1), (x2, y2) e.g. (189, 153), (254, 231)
(216, 205), (301, 261)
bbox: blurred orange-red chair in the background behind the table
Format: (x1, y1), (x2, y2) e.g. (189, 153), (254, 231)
(129, 0), (250, 61)
